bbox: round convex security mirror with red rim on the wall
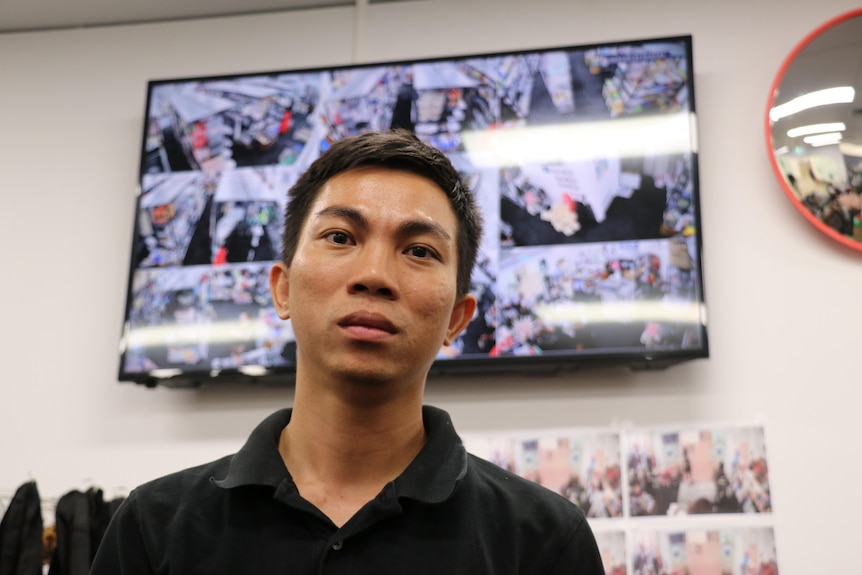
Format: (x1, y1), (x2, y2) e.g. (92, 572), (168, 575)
(766, 9), (862, 251)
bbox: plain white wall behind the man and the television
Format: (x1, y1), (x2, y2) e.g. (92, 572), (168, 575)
(0, 0), (862, 575)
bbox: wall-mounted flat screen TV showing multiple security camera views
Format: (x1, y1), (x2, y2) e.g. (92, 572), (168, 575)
(119, 36), (708, 386)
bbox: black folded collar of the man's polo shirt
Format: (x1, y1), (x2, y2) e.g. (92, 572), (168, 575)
(213, 406), (467, 503)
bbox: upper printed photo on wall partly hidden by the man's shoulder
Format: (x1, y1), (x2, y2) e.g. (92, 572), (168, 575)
(463, 430), (623, 519)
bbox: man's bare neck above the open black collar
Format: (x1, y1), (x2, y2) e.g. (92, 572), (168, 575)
(279, 381), (425, 526)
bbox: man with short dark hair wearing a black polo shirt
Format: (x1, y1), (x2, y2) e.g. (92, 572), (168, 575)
(91, 131), (604, 575)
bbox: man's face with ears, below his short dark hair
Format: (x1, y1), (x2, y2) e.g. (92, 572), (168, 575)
(271, 167), (476, 392)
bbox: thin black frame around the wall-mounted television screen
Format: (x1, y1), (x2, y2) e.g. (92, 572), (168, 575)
(123, 34), (709, 388)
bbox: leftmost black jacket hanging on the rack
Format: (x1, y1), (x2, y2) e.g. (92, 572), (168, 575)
(0, 481), (43, 575)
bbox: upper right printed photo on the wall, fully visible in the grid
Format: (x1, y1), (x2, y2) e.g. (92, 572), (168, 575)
(624, 427), (772, 517)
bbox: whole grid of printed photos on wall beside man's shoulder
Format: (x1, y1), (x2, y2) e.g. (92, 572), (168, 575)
(463, 425), (778, 575)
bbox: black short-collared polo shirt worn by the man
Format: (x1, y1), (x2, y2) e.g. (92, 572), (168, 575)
(90, 407), (604, 575)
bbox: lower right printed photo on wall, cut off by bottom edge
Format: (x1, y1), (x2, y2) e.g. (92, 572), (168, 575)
(631, 527), (778, 575)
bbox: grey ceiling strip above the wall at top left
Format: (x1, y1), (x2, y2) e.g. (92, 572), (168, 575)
(0, 0), (364, 33)
